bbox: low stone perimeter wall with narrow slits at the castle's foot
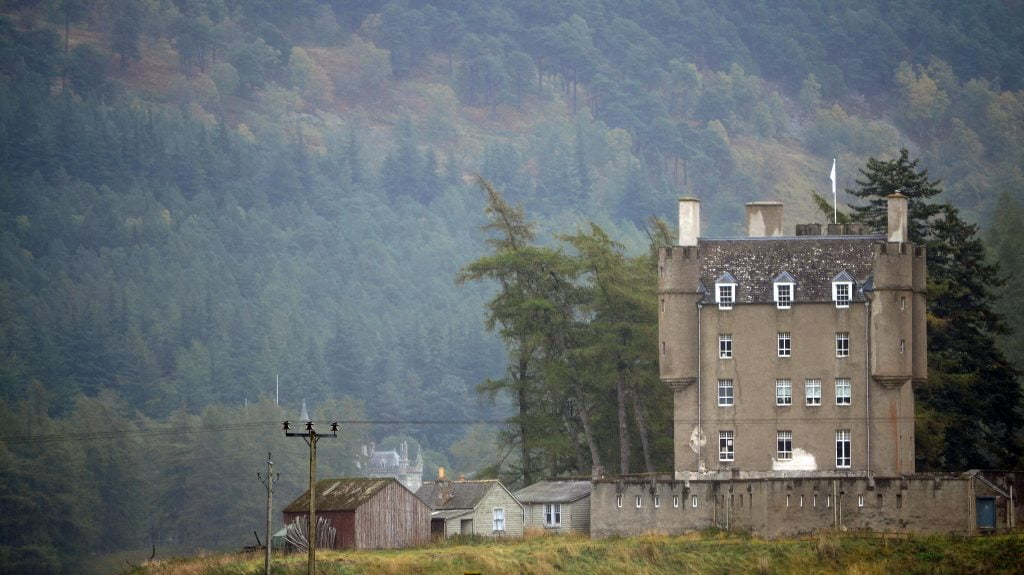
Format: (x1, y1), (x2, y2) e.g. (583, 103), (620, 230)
(591, 472), (1024, 538)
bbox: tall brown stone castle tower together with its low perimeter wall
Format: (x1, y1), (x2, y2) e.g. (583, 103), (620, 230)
(591, 193), (1024, 537)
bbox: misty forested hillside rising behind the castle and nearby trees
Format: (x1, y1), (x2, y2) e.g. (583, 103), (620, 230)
(0, 0), (1024, 572)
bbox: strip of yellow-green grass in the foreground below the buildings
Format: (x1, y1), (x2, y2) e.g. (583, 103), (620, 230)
(116, 532), (1024, 575)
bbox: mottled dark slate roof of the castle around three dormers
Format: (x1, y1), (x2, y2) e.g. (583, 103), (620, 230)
(697, 235), (884, 304)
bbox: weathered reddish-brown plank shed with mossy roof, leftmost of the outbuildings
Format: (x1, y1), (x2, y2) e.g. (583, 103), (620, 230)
(284, 478), (430, 549)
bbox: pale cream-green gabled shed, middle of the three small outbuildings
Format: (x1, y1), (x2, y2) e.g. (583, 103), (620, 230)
(416, 479), (522, 537)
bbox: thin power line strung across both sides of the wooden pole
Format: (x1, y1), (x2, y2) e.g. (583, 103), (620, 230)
(0, 419), (507, 445)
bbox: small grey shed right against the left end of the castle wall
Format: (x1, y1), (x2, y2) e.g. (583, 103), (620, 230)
(515, 480), (593, 535)
